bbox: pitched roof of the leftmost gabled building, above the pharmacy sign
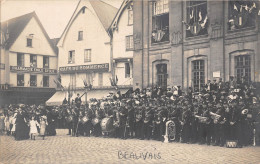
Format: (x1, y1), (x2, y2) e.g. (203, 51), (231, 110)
(1, 11), (56, 52)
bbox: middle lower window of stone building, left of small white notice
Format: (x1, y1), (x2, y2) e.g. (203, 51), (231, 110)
(192, 60), (205, 90)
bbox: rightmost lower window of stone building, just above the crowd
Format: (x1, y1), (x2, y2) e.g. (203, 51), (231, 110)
(235, 55), (251, 82)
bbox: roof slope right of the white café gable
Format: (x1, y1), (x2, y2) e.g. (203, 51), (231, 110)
(89, 0), (118, 31)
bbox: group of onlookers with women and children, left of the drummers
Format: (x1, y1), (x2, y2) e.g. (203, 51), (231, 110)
(0, 104), (57, 141)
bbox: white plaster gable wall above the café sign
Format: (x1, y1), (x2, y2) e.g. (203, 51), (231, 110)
(58, 3), (110, 67)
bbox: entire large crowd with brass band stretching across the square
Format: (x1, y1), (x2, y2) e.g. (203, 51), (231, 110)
(0, 77), (260, 147)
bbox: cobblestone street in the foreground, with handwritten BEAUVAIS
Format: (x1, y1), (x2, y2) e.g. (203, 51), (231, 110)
(0, 130), (260, 164)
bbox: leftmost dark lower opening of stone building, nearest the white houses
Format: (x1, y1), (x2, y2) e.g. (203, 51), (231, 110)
(156, 64), (167, 88)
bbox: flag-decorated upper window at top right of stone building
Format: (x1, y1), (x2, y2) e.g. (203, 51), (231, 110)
(228, 1), (257, 30)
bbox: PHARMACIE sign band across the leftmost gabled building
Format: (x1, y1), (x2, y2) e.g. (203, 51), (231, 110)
(10, 66), (57, 73)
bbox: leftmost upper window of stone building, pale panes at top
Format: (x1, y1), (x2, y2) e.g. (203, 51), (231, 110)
(152, 0), (169, 43)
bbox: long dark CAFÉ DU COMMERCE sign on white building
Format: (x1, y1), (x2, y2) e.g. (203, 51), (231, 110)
(59, 63), (109, 73)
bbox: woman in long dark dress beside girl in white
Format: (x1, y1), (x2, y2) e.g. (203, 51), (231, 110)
(15, 108), (30, 140)
